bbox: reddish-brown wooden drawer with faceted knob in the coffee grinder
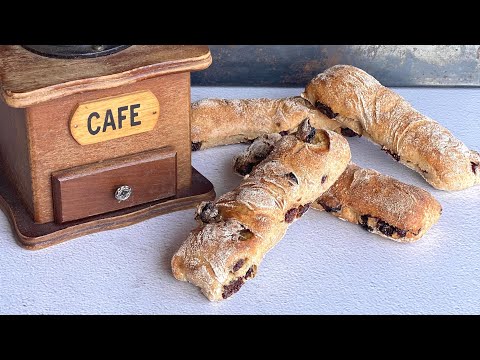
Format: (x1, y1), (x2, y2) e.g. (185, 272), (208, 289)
(52, 147), (177, 223)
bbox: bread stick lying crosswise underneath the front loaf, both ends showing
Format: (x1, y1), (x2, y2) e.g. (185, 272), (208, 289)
(234, 133), (442, 242)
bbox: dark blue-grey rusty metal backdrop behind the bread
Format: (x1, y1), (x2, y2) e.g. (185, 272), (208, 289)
(192, 45), (480, 87)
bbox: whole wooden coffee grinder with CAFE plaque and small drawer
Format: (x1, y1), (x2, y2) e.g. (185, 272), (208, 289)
(0, 45), (215, 249)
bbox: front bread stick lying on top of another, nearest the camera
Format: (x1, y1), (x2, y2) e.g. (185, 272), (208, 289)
(172, 121), (350, 301)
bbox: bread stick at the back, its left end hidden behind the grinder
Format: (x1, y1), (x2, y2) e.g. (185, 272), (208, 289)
(191, 96), (348, 151)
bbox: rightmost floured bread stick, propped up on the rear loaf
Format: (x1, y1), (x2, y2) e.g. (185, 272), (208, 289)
(302, 65), (480, 190)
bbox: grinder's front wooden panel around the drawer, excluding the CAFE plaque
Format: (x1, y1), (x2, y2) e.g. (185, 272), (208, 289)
(27, 72), (191, 223)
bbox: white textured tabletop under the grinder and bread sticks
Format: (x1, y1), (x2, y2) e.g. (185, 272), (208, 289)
(0, 88), (480, 314)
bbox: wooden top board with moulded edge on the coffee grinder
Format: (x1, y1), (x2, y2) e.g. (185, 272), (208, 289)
(0, 45), (212, 107)
